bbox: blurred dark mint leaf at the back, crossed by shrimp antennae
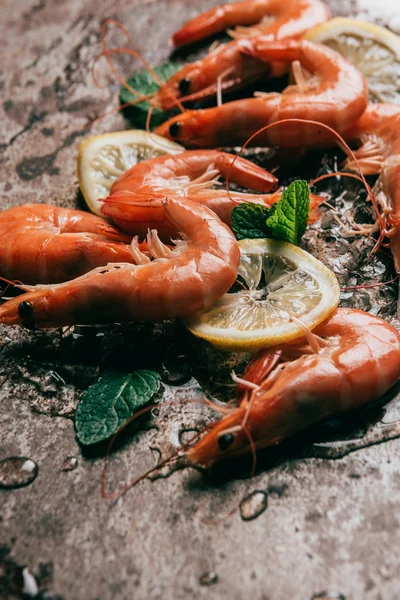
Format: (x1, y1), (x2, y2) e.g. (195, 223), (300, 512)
(119, 63), (181, 129)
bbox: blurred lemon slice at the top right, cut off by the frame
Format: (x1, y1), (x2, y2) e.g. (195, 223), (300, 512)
(305, 17), (400, 104)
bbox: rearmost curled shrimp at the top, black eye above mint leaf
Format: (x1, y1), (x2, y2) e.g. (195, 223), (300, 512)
(154, 0), (330, 110)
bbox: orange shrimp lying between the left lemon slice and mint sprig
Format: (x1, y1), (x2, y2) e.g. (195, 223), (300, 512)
(102, 150), (322, 239)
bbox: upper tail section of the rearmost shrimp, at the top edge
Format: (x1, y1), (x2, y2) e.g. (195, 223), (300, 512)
(172, 0), (331, 46)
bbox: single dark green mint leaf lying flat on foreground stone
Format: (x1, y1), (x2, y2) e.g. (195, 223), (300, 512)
(75, 371), (160, 445)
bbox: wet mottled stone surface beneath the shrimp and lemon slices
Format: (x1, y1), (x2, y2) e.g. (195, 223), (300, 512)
(0, 0), (400, 600)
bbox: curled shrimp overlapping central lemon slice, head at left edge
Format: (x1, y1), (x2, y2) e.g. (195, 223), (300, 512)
(0, 198), (240, 328)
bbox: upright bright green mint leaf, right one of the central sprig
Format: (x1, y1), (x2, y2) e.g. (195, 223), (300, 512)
(266, 179), (310, 245)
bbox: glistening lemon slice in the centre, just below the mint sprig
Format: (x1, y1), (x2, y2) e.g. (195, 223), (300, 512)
(184, 239), (340, 352)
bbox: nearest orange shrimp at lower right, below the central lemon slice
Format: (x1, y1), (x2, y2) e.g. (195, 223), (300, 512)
(186, 308), (400, 467)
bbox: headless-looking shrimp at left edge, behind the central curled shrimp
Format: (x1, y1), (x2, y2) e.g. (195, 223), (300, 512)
(0, 204), (134, 283)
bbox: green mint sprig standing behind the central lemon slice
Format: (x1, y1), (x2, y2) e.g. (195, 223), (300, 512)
(231, 180), (310, 245)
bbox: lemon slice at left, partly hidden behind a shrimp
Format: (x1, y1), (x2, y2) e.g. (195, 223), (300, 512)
(78, 129), (184, 215)
